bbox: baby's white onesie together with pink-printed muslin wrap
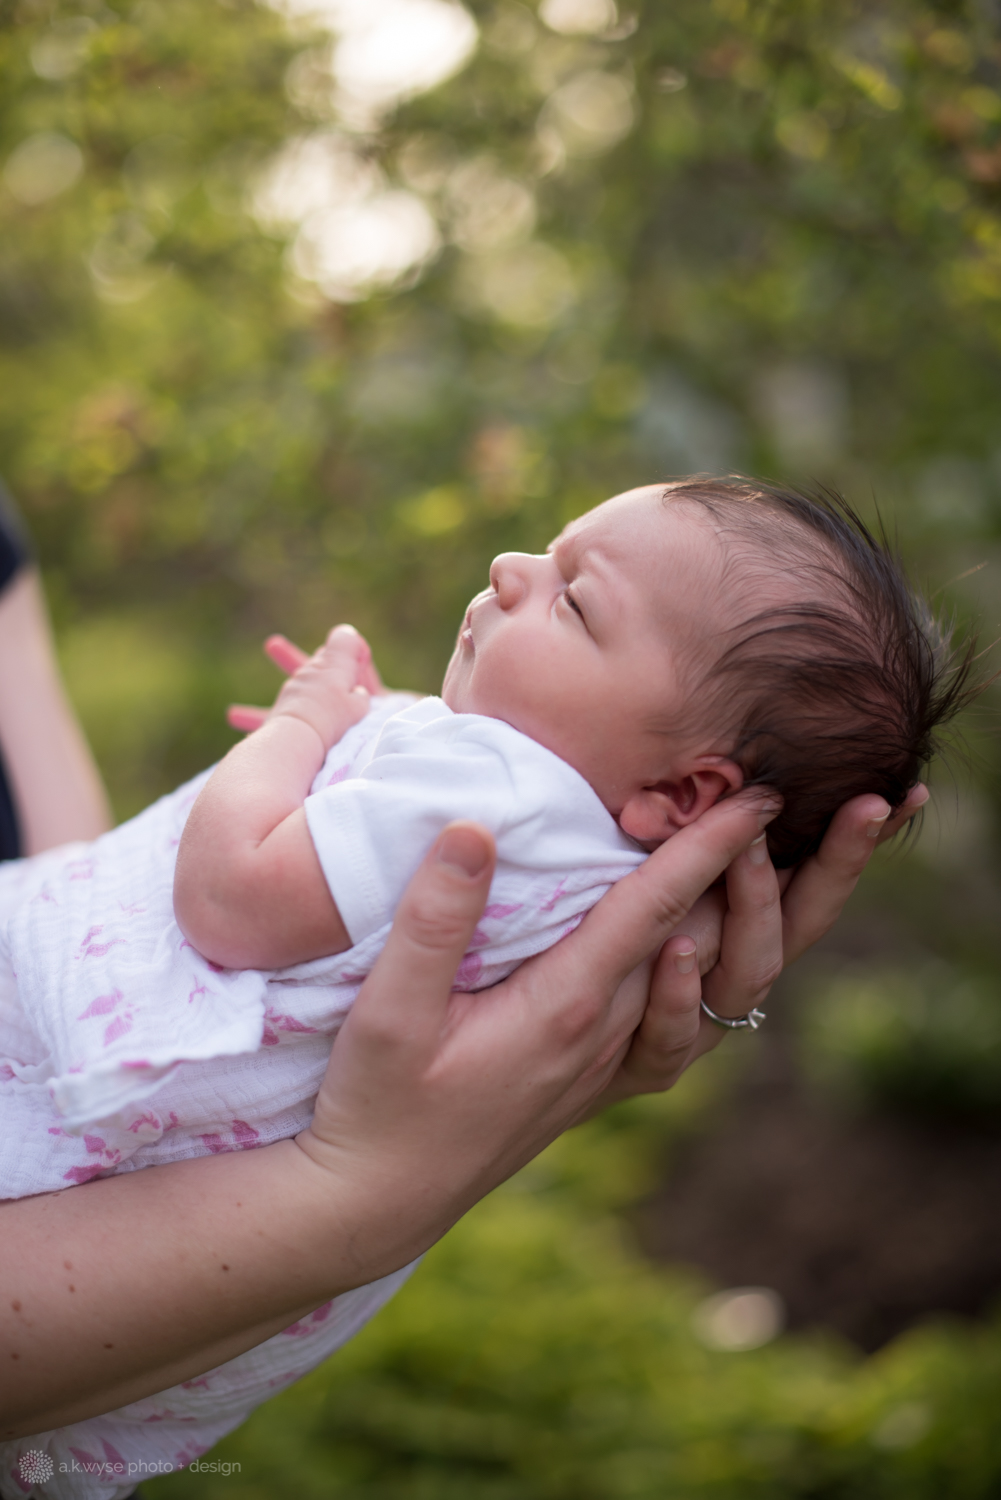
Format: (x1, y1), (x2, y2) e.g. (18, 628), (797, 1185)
(0, 693), (645, 1500)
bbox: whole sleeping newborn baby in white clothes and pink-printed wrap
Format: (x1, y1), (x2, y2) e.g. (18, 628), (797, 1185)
(0, 479), (968, 1500)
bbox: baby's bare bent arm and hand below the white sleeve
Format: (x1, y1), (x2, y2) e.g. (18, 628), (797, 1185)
(174, 626), (369, 969)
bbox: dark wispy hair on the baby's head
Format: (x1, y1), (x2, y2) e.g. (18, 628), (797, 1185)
(665, 476), (980, 867)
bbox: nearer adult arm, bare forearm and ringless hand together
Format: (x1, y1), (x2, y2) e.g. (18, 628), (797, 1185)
(0, 794), (768, 1439)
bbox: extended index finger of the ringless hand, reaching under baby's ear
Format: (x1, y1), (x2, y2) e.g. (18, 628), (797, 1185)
(537, 791), (779, 1026)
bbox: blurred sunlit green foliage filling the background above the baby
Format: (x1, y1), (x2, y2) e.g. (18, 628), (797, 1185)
(0, 0), (1001, 812)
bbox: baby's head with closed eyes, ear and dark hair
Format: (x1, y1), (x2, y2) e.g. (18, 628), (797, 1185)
(443, 479), (971, 864)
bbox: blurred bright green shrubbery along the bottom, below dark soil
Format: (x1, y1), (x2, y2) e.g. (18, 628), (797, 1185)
(144, 1112), (1001, 1500)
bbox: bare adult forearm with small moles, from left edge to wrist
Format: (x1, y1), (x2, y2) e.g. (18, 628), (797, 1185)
(0, 1140), (390, 1439)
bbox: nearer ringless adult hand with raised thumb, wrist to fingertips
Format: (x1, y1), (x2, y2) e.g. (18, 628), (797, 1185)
(299, 789), (777, 1277)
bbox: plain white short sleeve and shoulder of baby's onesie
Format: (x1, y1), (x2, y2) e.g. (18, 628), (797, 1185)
(306, 698), (644, 984)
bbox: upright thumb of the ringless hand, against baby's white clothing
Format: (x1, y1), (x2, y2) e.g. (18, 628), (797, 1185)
(348, 822), (495, 1056)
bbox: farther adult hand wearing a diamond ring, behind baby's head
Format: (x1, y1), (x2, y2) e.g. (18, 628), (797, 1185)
(593, 783), (929, 1113)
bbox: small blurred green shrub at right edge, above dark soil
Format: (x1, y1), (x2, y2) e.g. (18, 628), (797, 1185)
(804, 959), (1001, 1119)
